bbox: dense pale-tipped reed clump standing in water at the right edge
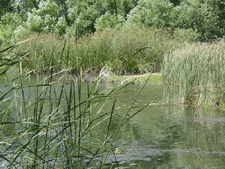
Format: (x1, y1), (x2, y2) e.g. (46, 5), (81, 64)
(163, 40), (225, 106)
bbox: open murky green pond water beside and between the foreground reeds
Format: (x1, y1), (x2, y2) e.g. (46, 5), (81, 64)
(0, 74), (225, 169)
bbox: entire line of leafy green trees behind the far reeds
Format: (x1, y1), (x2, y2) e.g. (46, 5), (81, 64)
(0, 0), (225, 41)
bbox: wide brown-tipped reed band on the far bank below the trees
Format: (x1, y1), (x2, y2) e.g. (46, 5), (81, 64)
(15, 29), (185, 74)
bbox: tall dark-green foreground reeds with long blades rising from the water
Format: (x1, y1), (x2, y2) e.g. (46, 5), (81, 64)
(0, 40), (147, 168)
